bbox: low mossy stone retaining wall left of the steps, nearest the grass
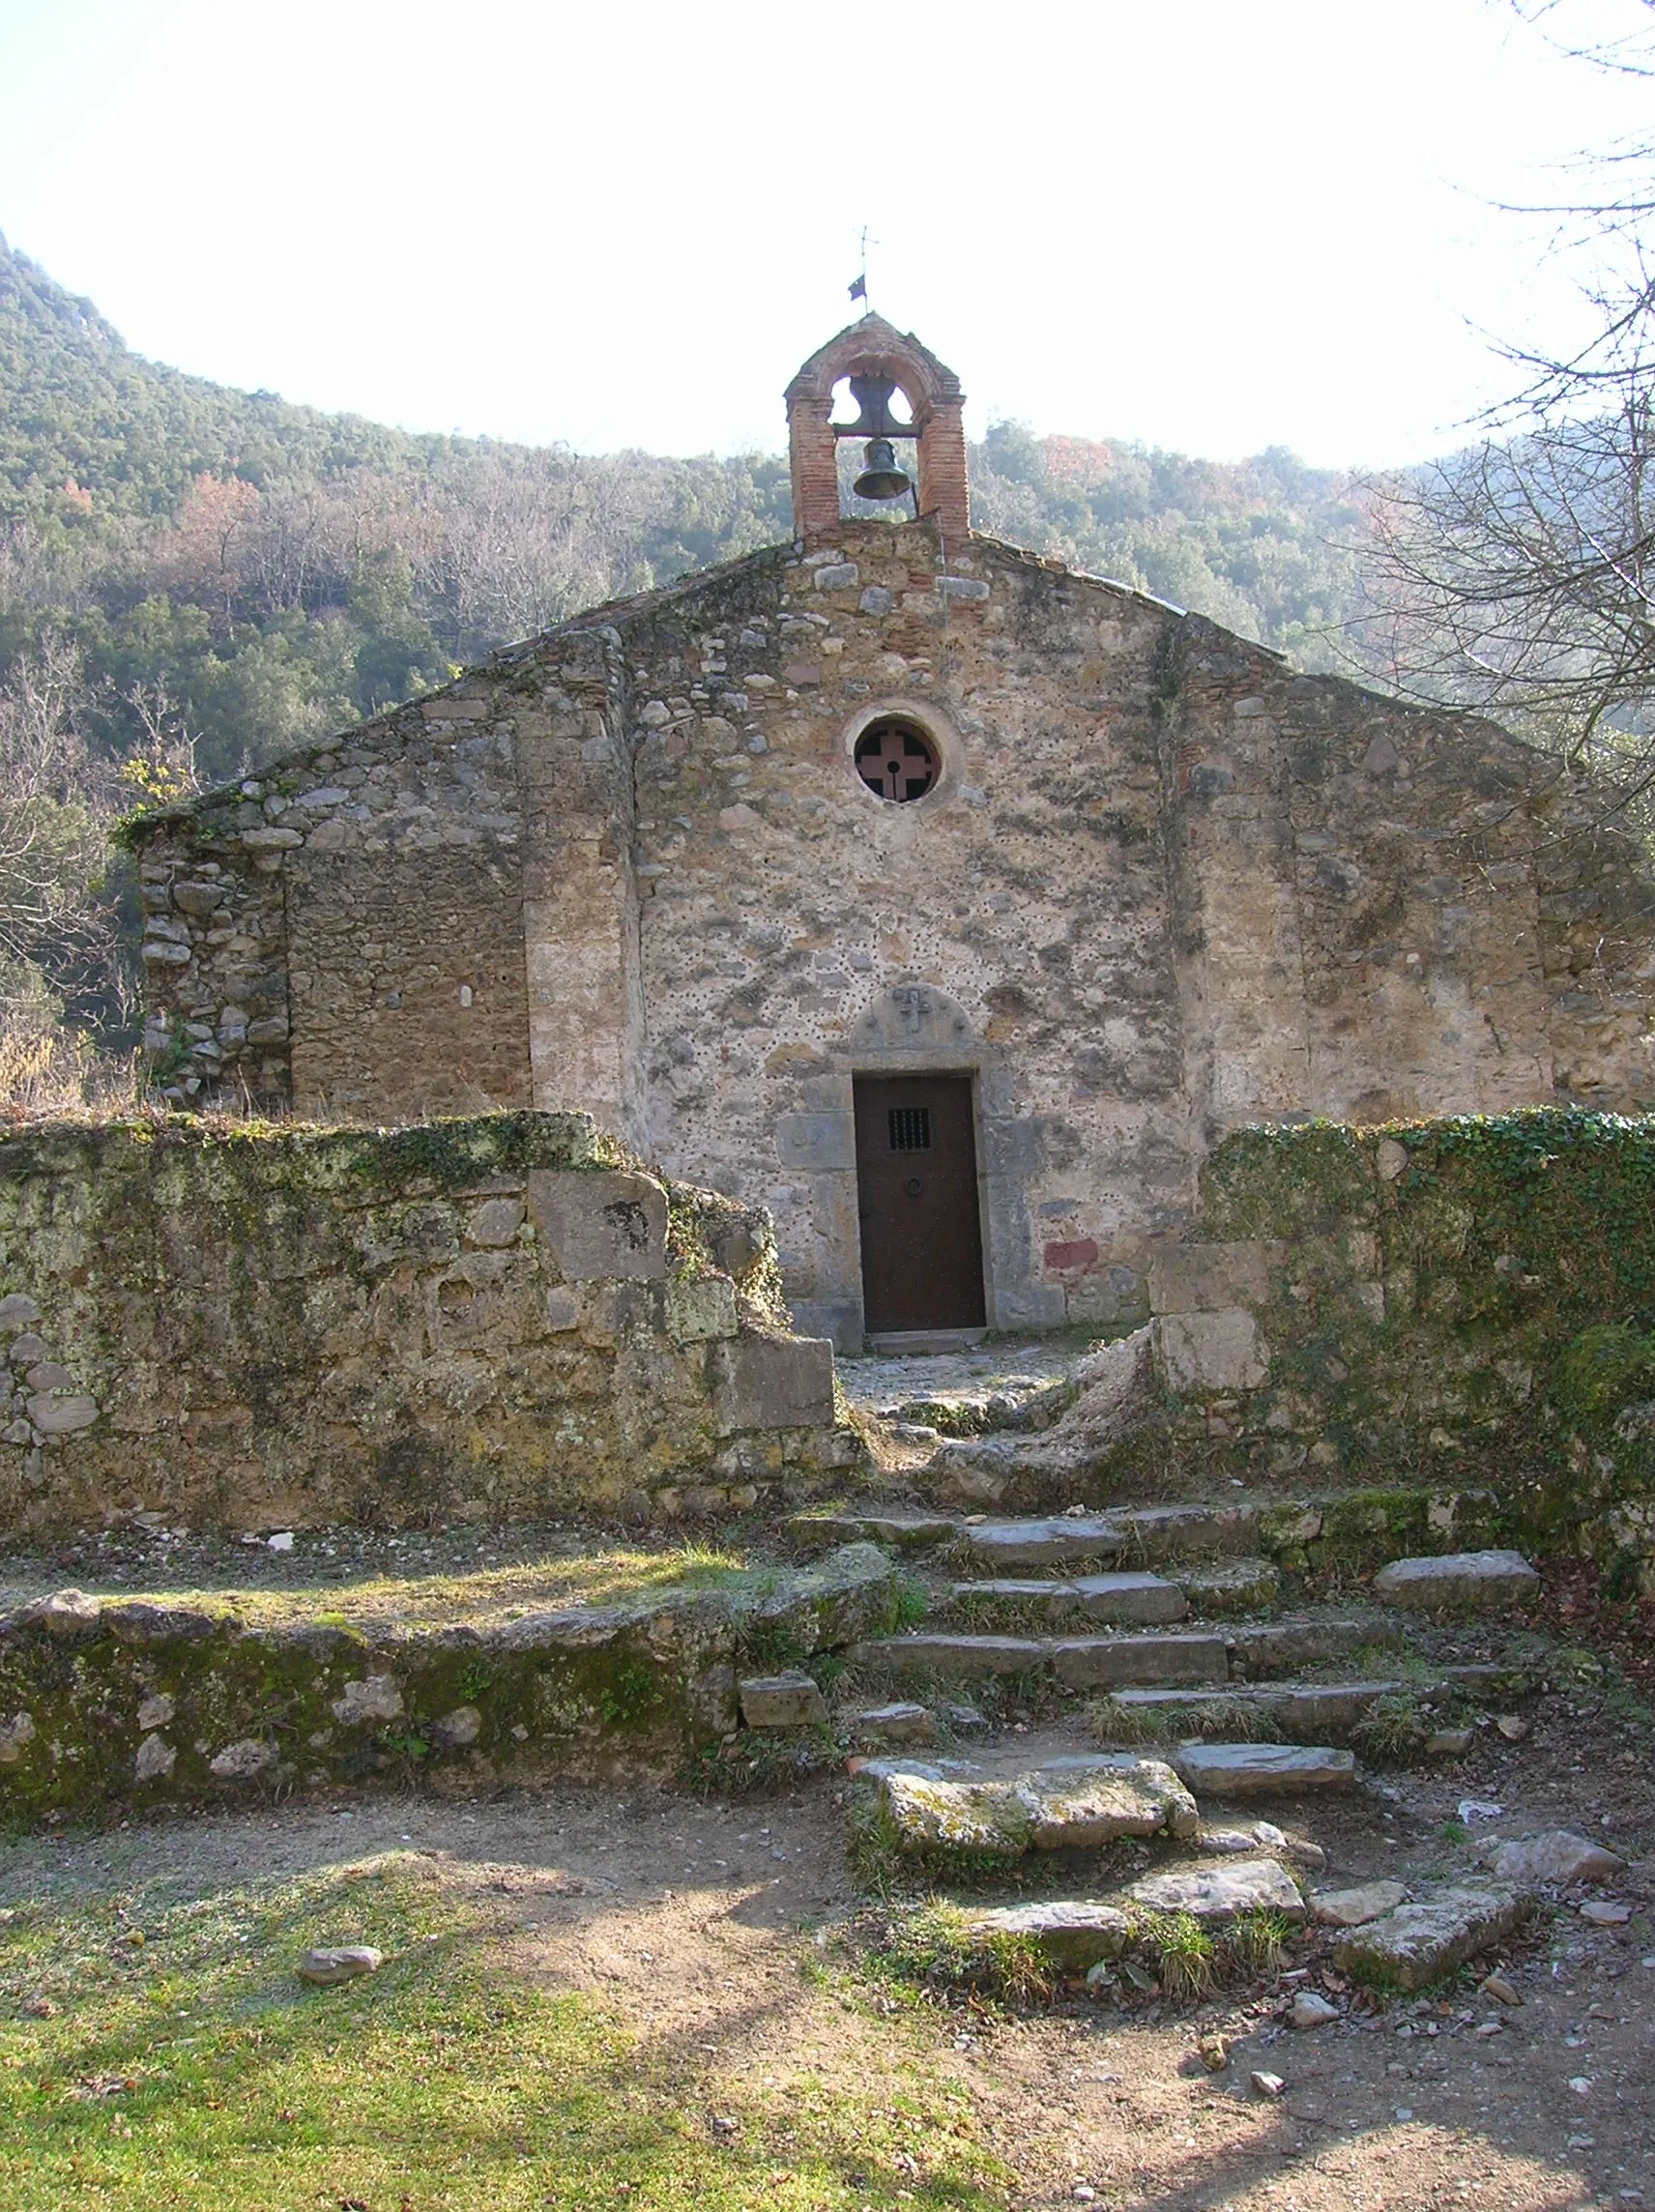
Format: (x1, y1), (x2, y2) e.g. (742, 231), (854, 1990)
(0, 1544), (898, 1820)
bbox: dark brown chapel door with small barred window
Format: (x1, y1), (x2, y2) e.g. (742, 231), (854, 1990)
(857, 1075), (985, 1331)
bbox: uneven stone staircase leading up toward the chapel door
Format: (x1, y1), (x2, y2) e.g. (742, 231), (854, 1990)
(790, 1441), (1538, 1989)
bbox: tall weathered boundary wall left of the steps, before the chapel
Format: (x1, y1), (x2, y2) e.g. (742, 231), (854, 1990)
(0, 1113), (860, 1539)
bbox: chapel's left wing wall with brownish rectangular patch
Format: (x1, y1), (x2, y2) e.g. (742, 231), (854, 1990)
(135, 632), (642, 1137)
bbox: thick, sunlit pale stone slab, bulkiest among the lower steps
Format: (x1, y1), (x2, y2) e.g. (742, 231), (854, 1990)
(857, 1759), (1200, 1858)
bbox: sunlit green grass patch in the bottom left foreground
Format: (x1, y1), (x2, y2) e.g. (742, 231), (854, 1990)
(0, 1853), (1009, 2212)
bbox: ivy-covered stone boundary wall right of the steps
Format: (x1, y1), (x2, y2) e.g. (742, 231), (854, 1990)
(1135, 1108), (1655, 1595)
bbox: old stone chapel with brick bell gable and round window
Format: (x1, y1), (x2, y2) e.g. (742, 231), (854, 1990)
(137, 314), (1655, 1350)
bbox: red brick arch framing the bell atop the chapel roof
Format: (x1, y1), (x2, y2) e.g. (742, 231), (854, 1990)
(786, 314), (972, 539)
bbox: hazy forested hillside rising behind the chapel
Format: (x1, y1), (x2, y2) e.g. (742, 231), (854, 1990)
(0, 239), (1363, 1053)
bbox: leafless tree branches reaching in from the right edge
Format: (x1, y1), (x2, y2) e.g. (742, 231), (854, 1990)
(1361, 0), (1655, 805)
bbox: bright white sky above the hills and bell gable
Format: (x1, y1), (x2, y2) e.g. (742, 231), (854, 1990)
(0, 0), (1655, 467)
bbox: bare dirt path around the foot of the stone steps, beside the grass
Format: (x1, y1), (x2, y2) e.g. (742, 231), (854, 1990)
(0, 1710), (1655, 2212)
